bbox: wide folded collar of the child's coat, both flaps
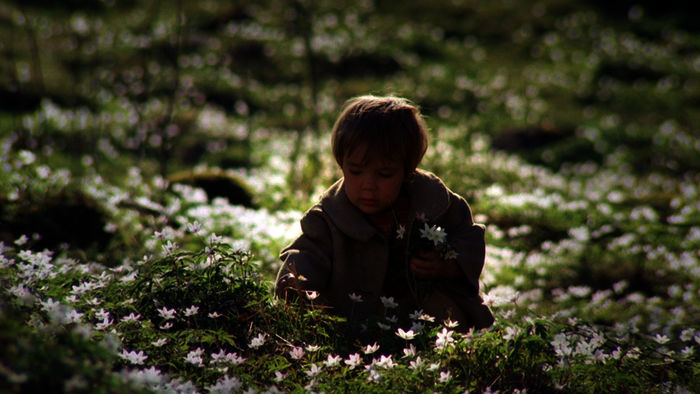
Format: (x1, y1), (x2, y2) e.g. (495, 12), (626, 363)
(320, 170), (449, 241)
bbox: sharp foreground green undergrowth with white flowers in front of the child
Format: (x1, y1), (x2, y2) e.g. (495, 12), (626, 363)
(0, 237), (699, 392)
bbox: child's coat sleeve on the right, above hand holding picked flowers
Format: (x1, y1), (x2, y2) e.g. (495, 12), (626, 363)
(438, 192), (486, 295)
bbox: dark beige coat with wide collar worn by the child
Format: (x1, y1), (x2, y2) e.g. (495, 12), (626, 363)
(276, 170), (493, 328)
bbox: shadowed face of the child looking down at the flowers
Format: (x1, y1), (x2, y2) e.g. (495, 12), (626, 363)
(342, 149), (404, 215)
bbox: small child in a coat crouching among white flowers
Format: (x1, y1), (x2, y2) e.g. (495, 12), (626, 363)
(275, 96), (493, 331)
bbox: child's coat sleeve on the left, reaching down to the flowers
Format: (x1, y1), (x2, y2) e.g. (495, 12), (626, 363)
(275, 207), (333, 302)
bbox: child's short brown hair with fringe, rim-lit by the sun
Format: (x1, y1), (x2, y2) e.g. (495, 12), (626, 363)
(332, 96), (428, 175)
